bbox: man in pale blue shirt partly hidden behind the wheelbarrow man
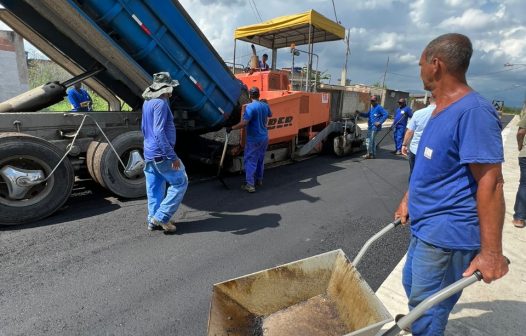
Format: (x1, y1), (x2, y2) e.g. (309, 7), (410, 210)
(402, 97), (436, 179)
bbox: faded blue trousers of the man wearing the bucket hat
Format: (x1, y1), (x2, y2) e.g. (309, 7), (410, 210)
(144, 160), (188, 224)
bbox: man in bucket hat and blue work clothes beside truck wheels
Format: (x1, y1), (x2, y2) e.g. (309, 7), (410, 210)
(141, 72), (188, 233)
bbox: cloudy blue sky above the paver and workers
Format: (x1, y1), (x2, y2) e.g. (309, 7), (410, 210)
(0, 0), (526, 107)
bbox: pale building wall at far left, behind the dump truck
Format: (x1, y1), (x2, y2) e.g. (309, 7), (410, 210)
(0, 30), (29, 102)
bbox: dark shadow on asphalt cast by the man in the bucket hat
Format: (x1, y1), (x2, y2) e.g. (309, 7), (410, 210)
(176, 212), (281, 235)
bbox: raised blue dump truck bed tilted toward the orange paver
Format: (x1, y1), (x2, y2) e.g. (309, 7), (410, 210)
(0, 0), (242, 130)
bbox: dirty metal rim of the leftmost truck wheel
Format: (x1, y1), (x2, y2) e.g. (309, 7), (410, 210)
(0, 156), (55, 207)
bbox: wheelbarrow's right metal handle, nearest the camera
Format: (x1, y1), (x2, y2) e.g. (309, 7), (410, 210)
(380, 258), (510, 336)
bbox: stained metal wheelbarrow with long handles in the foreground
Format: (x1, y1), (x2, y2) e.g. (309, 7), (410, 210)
(208, 220), (502, 336)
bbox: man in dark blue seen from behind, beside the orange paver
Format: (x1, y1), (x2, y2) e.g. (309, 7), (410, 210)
(226, 87), (272, 193)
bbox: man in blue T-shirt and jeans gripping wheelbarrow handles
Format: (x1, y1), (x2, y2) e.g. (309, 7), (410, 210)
(395, 34), (508, 336)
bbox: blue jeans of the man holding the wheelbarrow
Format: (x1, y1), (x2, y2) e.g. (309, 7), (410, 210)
(402, 236), (478, 336)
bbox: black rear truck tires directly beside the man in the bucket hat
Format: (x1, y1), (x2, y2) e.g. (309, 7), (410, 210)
(86, 131), (146, 198)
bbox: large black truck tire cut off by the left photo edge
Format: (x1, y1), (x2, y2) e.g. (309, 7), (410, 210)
(0, 133), (75, 225)
